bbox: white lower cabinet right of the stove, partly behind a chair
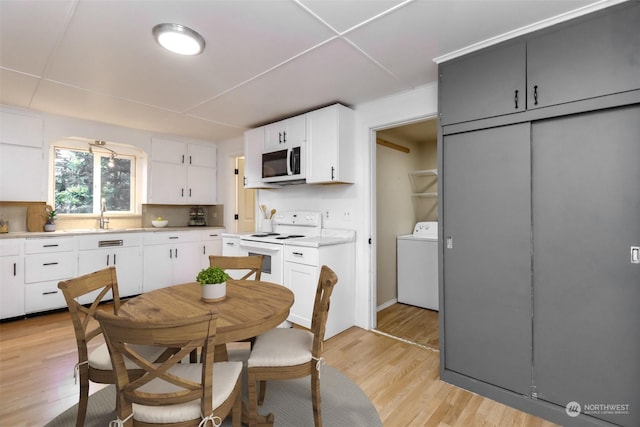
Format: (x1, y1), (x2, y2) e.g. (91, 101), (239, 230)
(284, 243), (355, 339)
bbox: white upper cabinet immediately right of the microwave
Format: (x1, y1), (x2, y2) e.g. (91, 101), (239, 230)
(306, 104), (355, 184)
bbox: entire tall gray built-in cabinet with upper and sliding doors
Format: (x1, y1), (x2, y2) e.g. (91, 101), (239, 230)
(439, 2), (640, 427)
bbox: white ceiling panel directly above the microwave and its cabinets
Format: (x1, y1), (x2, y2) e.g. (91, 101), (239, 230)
(191, 38), (408, 127)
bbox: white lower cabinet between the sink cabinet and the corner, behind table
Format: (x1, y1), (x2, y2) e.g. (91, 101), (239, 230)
(143, 231), (202, 292)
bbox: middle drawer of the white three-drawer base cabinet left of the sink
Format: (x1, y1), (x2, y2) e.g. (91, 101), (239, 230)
(24, 252), (76, 283)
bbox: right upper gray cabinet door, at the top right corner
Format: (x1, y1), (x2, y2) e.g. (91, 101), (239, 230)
(527, 2), (640, 109)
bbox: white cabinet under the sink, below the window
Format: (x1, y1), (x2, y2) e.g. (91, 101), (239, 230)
(78, 233), (142, 304)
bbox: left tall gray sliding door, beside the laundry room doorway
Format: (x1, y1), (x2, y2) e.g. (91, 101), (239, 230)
(442, 123), (532, 395)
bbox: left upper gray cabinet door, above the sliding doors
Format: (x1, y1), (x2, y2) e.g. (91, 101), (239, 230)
(440, 42), (526, 125)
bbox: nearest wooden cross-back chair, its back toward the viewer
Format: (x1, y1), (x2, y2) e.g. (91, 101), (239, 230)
(96, 311), (242, 427)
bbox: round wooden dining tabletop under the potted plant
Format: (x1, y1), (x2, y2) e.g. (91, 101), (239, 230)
(118, 280), (293, 344)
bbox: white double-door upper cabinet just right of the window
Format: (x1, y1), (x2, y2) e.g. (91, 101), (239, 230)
(148, 138), (217, 204)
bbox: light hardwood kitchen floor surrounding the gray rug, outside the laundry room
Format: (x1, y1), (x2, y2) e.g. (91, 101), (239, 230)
(0, 312), (554, 427)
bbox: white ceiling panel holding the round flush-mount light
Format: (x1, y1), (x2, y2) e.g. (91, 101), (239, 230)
(47, 1), (331, 112)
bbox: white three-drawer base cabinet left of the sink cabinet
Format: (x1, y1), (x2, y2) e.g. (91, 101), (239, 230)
(24, 236), (77, 313)
